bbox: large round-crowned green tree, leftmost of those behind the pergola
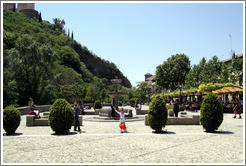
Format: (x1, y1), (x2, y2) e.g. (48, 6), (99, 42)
(156, 54), (190, 90)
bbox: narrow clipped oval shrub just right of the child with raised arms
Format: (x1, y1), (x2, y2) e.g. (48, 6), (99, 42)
(148, 95), (167, 133)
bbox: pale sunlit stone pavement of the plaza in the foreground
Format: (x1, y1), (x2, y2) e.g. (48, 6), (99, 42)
(2, 106), (245, 164)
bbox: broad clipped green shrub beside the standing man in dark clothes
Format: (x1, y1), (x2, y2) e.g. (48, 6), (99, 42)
(48, 99), (74, 134)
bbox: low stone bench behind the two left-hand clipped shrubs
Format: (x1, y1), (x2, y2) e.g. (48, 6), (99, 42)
(26, 115), (83, 126)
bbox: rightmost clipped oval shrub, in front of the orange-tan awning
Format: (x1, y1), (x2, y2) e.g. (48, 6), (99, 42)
(200, 93), (223, 132)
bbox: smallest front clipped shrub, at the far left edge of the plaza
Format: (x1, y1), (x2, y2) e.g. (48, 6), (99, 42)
(3, 106), (21, 135)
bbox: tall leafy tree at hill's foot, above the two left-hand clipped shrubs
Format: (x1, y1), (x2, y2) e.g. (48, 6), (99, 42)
(10, 35), (55, 105)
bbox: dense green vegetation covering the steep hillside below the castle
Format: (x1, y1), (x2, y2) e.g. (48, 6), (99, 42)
(3, 11), (131, 107)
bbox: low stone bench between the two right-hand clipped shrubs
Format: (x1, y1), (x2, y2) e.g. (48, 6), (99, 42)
(144, 114), (200, 126)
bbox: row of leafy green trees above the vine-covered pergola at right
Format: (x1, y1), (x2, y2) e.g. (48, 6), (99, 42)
(156, 53), (243, 96)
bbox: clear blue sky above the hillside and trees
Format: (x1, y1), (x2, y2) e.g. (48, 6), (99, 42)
(35, 2), (244, 86)
